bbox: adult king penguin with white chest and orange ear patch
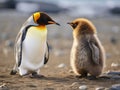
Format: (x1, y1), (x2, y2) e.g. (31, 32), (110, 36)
(10, 12), (59, 76)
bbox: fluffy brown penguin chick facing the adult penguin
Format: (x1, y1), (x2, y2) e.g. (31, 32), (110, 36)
(68, 18), (105, 77)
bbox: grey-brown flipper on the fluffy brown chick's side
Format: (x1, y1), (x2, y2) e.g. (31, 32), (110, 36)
(89, 42), (100, 64)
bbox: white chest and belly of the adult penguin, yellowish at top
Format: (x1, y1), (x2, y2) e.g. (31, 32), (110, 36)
(21, 28), (47, 70)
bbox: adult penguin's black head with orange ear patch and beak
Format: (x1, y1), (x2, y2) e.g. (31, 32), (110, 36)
(33, 12), (60, 25)
